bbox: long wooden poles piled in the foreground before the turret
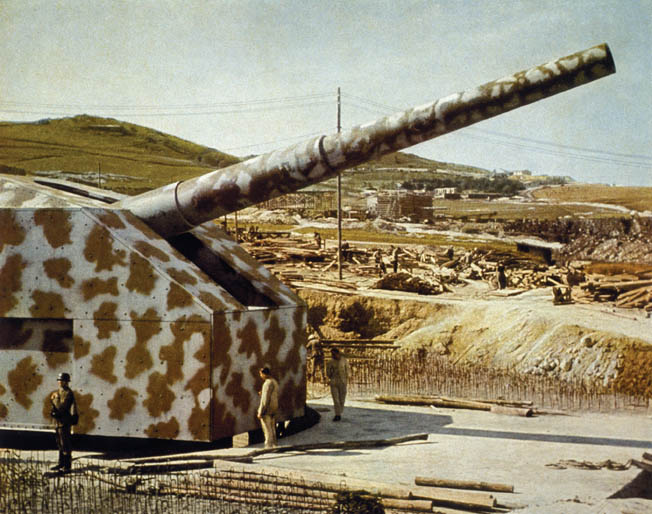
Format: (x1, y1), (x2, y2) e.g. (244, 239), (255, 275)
(112, 434), (513, 513)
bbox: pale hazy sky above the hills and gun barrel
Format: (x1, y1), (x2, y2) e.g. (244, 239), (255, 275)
(0, 0), (652, 186)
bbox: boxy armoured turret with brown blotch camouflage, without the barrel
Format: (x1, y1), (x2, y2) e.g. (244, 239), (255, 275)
(0, 177), (305, 441)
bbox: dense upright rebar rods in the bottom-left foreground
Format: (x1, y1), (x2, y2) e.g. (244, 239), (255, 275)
(0, 450), (398, 514)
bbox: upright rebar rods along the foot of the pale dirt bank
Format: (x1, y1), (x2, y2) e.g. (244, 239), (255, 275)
(309, 349), (650, 412)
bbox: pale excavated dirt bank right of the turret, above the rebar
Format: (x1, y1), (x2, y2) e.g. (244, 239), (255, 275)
(301, 290), (652, 396)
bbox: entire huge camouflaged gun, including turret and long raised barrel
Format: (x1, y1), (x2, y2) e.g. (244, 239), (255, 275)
(0, 45), (615, 441)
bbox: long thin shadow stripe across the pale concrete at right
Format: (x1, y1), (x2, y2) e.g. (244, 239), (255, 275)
(432, 427), (652, 448)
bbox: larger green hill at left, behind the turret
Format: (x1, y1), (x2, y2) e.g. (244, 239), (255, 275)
(0, 115), (240, 194)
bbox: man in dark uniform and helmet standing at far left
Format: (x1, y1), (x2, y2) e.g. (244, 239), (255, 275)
(50, 373), (78, 473)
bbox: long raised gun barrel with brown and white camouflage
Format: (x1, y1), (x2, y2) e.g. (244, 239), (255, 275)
(115, 44), (616, 237)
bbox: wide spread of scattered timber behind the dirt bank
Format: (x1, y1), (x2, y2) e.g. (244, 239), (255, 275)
(243, 233), (652, 312)
